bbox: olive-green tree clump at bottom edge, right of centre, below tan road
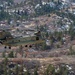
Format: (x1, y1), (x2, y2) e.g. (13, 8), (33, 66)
(44, 64), (69, 75)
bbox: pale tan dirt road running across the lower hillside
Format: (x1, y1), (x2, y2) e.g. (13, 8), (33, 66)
(0, 55), (75, 64)
